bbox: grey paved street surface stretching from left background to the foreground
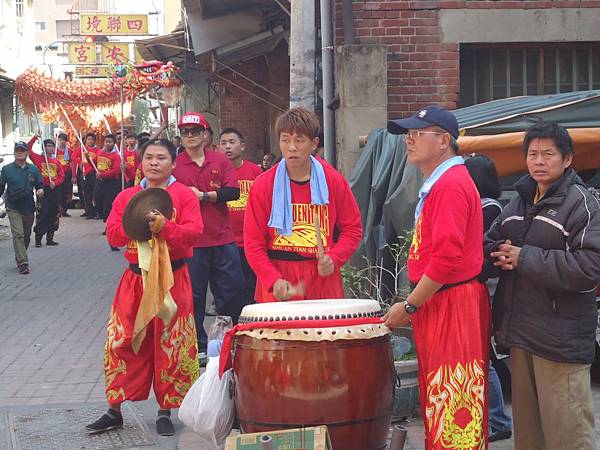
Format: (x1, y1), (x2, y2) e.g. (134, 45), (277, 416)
(0, 210), (600, 450)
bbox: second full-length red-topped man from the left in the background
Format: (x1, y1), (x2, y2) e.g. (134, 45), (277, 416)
(73, 132), (100, 220)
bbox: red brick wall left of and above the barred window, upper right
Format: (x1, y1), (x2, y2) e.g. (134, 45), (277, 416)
(334, 0), (600, 118)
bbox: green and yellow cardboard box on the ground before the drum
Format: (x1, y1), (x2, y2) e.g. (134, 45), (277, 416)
(225, 425), (332, 450)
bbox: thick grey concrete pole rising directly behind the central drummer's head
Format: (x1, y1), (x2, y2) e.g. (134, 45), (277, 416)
(290, 0), (316, 111)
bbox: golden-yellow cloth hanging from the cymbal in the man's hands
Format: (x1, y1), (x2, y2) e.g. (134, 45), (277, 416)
(131, 236), (177, 354)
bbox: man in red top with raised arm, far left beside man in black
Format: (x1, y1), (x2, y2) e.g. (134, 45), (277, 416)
(28, 136), (65, 247)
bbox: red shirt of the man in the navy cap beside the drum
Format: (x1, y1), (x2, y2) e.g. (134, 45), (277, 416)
(408, 165), (483, 284)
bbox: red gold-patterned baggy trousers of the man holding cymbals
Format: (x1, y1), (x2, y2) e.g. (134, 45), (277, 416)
(104, 265), (199, 409)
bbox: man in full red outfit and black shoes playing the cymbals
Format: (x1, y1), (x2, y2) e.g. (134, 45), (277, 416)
(86, 139), (203, 436)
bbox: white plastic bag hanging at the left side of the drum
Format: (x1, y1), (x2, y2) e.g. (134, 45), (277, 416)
(179, 357), (235, 447)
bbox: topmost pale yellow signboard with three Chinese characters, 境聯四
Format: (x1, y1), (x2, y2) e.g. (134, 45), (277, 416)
(79, 14), (148, 36)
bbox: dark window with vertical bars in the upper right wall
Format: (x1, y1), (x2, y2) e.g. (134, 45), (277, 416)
(460, 43), (600, 107)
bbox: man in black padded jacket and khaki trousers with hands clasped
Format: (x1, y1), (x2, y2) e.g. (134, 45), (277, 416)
(484, 122), (600, 450)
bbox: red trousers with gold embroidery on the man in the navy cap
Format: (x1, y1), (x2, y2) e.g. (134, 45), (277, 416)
(412, 280), (491, 450)
